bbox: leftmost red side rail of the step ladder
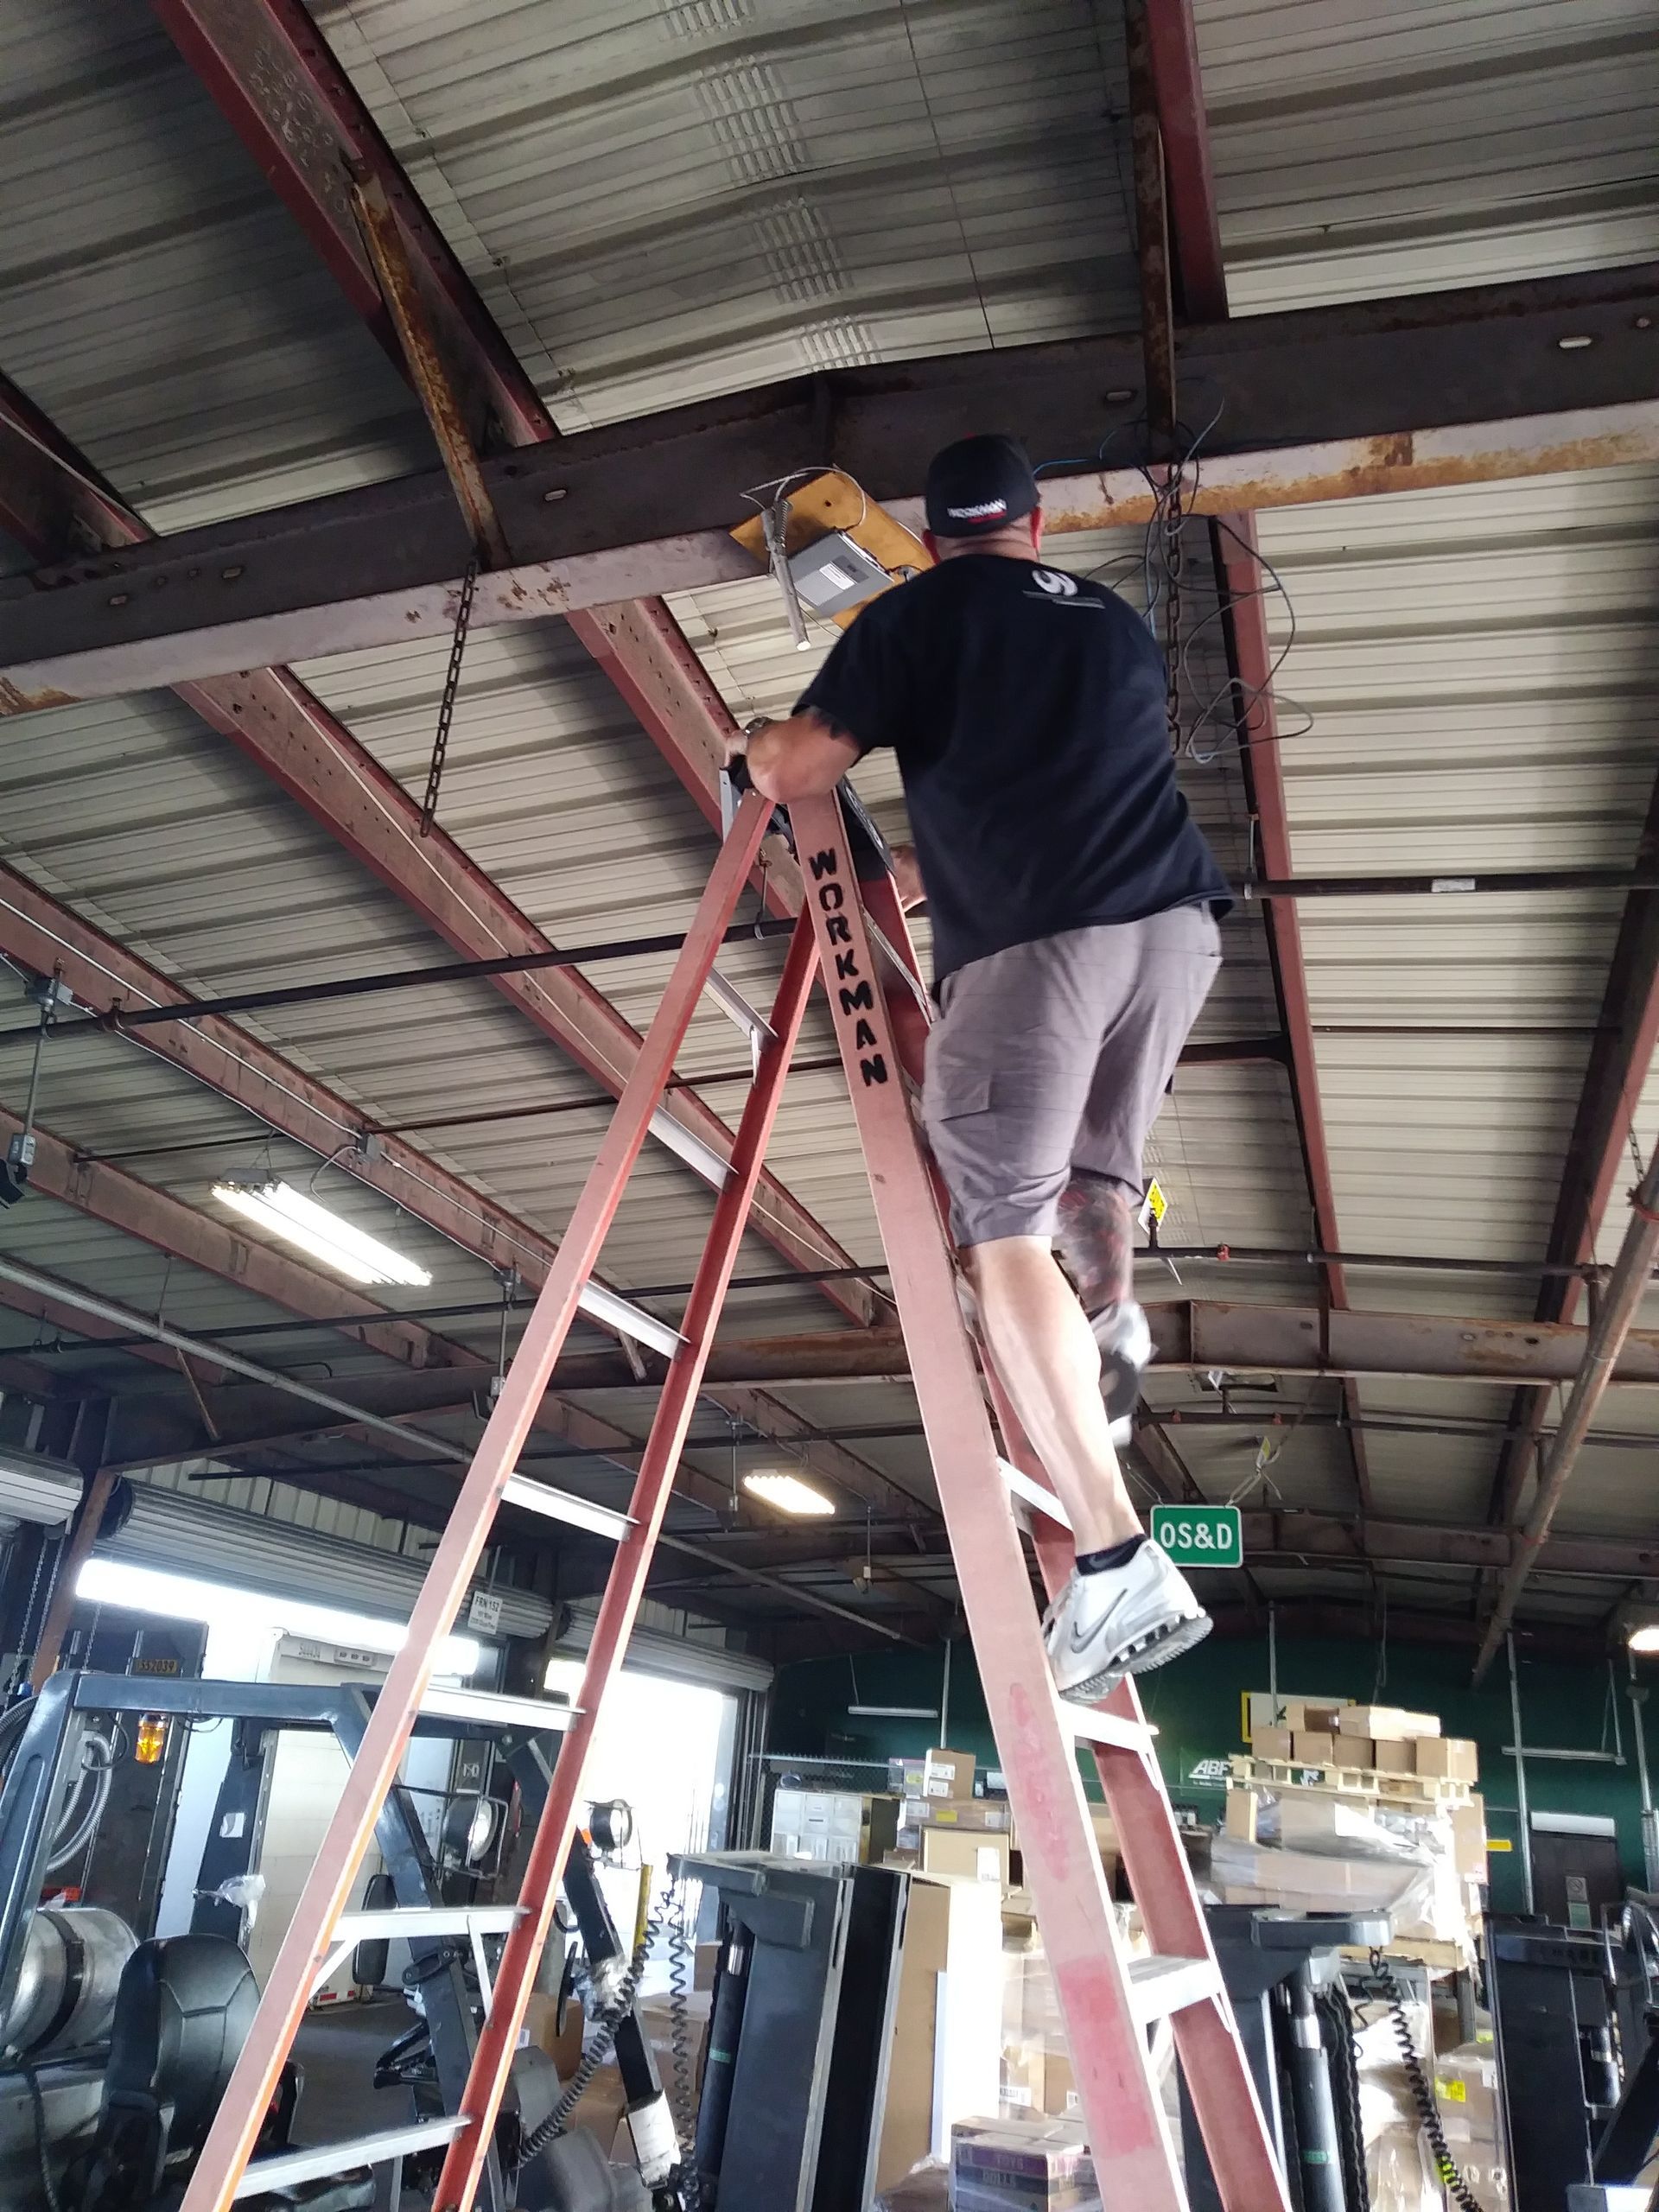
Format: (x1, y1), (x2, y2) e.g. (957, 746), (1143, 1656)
(179, 794), (772, 2212)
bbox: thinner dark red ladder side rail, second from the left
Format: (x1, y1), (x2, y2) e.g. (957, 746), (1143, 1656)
(434, 902), (818, 2212)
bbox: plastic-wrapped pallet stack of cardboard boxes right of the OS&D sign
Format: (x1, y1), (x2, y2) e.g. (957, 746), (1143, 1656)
(1212, 1692), (1486, 1967)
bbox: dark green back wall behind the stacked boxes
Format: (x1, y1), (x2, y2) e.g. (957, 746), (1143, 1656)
(770, 1635), (1659, 1911)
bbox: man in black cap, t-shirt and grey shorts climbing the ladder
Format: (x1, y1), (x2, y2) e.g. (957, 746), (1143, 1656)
(734, 435), (1232, 1703)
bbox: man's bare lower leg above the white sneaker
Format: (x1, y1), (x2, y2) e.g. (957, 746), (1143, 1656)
(963, 1236), (1141, 1551)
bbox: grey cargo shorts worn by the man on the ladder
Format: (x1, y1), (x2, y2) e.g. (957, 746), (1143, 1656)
(923, 907), (1221, 1245)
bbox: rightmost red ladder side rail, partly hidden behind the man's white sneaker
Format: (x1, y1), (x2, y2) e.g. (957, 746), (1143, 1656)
(984, 1282), (1289, 2212)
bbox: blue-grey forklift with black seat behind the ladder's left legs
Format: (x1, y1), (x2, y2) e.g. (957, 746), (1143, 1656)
(0, 1670), (683, 2212)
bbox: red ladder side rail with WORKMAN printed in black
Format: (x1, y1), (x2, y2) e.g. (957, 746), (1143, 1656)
(790, 798), (1185, 2212)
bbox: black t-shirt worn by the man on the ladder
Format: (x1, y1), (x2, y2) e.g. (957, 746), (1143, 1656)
(797, 553), (1232, 982)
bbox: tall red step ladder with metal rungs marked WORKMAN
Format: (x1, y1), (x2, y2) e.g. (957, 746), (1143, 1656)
(181, 791), (1287, 2212)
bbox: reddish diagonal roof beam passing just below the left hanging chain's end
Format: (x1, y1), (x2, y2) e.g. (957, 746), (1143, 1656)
(0, 380), (876, 1320)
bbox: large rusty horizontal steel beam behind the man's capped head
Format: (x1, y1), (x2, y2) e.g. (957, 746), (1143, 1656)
(0, 265), (1659, 712)
